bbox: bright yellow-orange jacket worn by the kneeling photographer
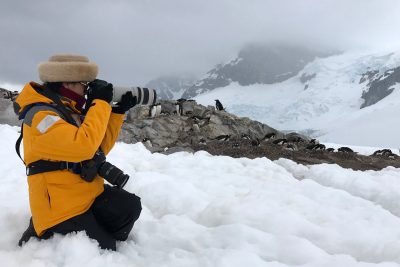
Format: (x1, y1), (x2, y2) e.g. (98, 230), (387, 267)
(15, 82), (124, 236)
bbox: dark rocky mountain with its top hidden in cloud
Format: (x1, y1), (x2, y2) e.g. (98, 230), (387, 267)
(182, 45), (327, 98)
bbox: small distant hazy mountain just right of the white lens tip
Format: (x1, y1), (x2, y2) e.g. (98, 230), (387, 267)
(146, 76), (196, 100)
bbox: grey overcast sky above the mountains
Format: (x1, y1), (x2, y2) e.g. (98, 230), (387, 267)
(0, 0), (400, 85)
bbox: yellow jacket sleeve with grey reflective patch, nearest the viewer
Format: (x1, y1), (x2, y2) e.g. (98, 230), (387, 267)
(30, 99), (111, 162)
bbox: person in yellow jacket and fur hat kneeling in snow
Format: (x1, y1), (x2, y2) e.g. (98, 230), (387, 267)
(14, 54), (142, 251)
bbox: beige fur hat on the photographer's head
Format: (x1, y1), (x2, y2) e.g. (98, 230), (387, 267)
(38, 54), (98, 82)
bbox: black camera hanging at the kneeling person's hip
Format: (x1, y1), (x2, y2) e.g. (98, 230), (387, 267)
(81, 150), (129, 188)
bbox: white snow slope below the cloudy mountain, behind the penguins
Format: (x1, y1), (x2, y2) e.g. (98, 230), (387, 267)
(195, 52), (400, 148)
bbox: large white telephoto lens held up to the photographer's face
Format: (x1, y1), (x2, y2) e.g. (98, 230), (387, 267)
(113, 86), (157, 106)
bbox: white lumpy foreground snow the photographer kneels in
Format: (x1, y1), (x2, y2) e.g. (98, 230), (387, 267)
(0, 125), (400, 267)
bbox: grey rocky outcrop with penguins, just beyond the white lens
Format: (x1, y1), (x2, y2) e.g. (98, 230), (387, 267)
(120, 100), (285, 151)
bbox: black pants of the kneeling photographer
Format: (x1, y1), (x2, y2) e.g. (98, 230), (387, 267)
(21, 185), (142, 250)
